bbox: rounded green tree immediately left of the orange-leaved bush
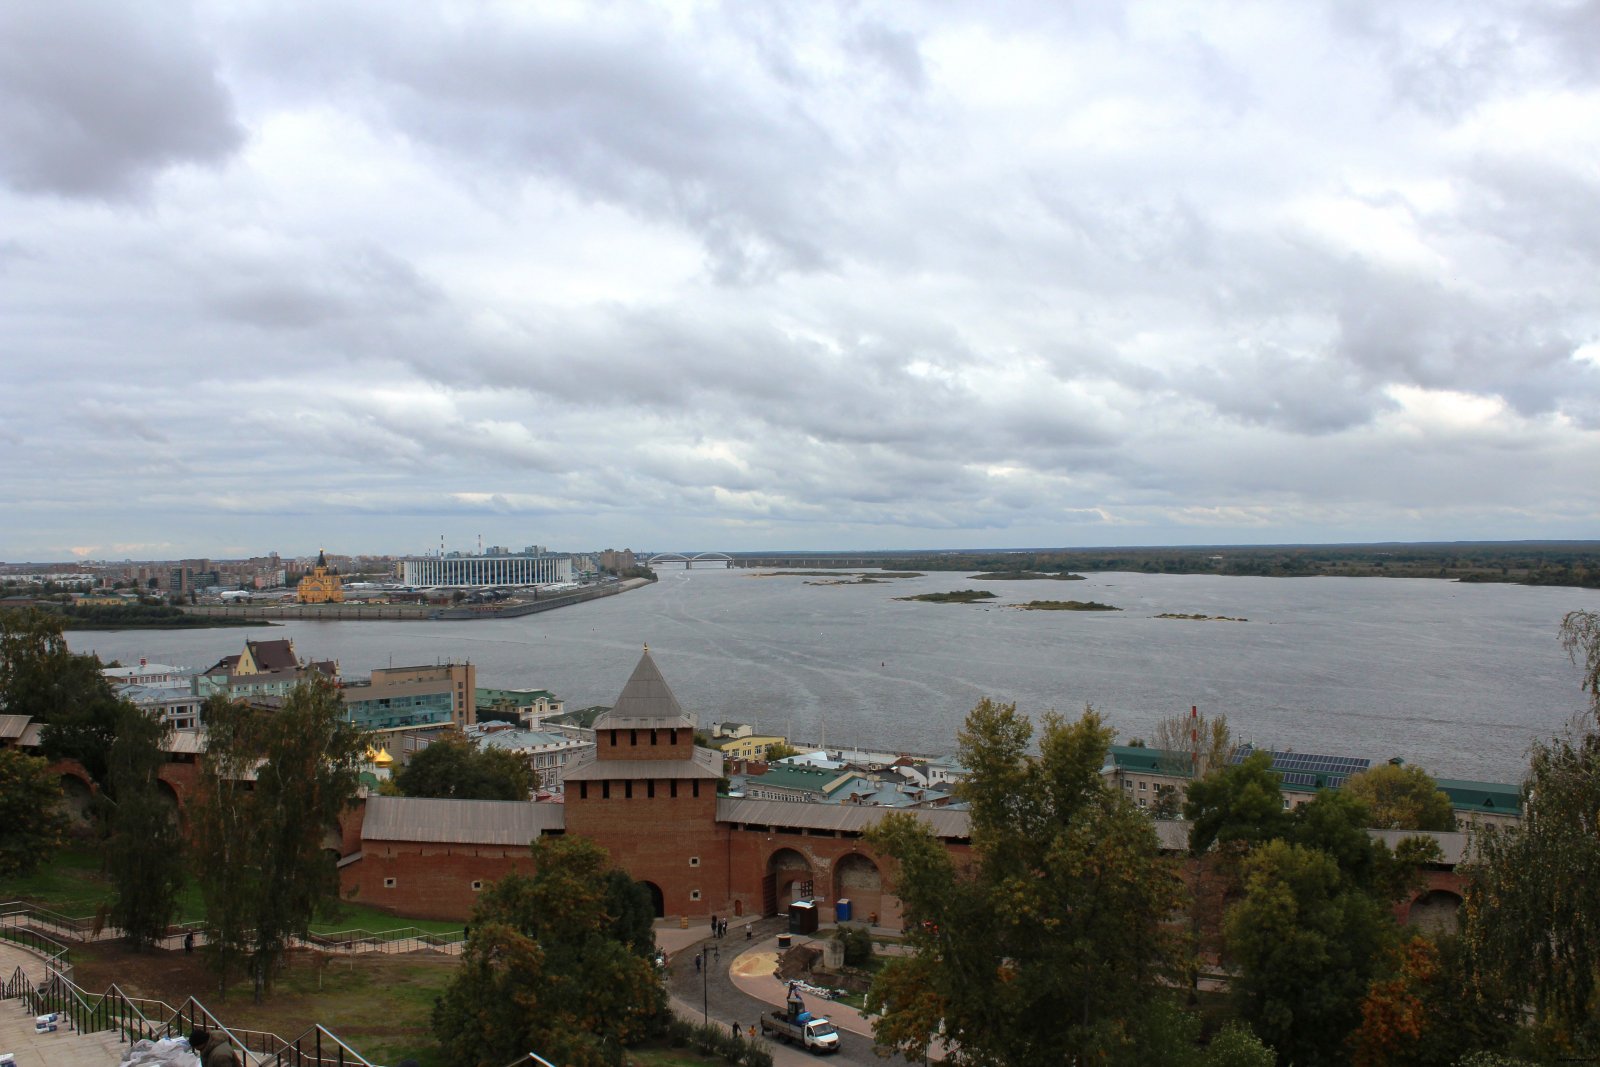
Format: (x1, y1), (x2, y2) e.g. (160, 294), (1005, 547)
(1226, 840), (1395, 1067)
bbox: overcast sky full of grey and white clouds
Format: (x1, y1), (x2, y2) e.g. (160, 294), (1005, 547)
(0, 0), (1600, 560)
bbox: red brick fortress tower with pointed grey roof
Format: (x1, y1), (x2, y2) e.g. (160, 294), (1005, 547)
(565, 645), (731, 915)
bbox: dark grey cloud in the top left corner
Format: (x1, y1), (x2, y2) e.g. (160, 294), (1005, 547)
(0, 0), (245, 198)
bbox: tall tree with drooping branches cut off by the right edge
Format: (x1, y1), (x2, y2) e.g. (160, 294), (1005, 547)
(1464, 611), (1600, 1053)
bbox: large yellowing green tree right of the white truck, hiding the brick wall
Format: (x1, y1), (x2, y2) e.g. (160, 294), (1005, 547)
(869, 701), (1182, 1067)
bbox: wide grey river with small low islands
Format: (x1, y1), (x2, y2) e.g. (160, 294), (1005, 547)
(69, 568), (1600, 782)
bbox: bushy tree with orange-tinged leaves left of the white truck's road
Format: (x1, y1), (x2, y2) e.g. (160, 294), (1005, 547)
(434, 837), (666, 1067)
